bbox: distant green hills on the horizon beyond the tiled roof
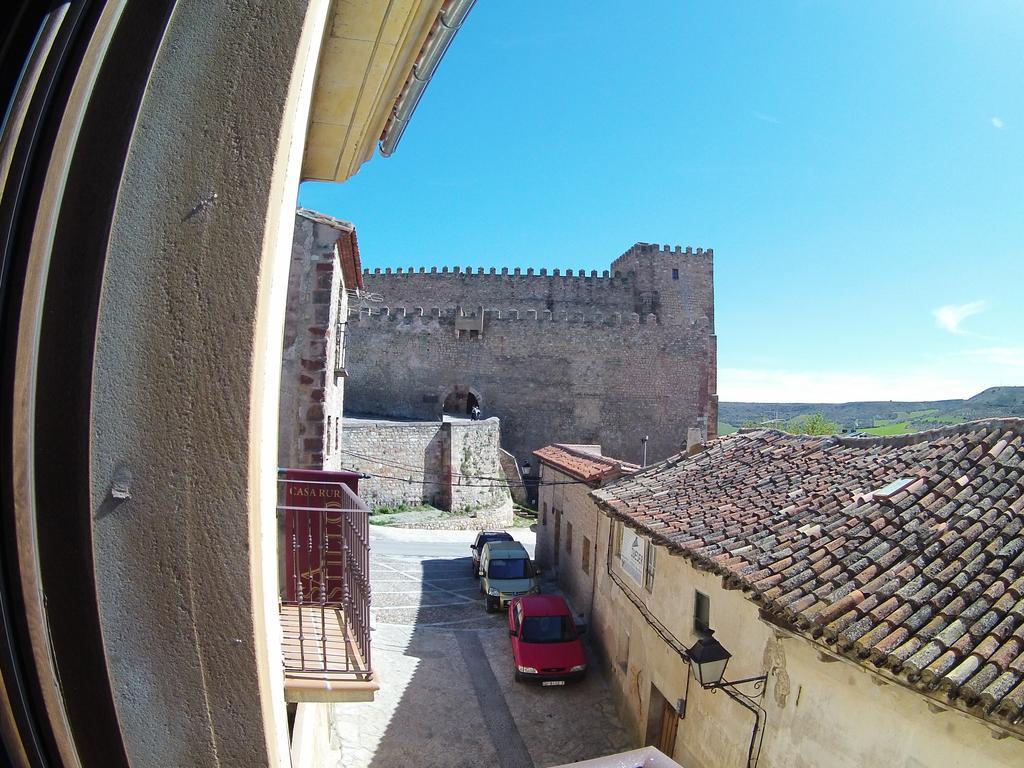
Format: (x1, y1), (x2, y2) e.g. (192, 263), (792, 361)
(718, 387), (1024, 434)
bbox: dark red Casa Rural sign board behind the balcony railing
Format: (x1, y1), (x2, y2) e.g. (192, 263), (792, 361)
(280, 469), (359, 604)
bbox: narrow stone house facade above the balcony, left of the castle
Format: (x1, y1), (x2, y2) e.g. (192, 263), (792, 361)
(278, 214), (362, 469)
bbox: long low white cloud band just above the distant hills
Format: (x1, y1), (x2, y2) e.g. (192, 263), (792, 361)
(718, 364), (991, 402)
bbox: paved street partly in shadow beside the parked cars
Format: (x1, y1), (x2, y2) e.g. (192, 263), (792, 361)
(332, 528), (631, 768)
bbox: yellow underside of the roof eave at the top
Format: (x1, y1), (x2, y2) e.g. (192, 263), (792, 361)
(302, 0), (444, 181)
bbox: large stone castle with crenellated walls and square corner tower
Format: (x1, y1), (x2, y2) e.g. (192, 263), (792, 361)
(346, 243), (718, 462)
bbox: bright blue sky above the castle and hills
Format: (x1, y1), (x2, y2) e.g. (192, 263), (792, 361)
(300, 0), (1024, 401)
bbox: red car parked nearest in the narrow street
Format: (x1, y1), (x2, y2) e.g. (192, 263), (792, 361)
(509, 595), (587, 685)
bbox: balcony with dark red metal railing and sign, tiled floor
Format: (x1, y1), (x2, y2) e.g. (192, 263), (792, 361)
(278, 476), (373, 680)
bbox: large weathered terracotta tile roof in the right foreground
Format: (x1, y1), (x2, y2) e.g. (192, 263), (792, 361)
(593, 419), (1024, 732)
